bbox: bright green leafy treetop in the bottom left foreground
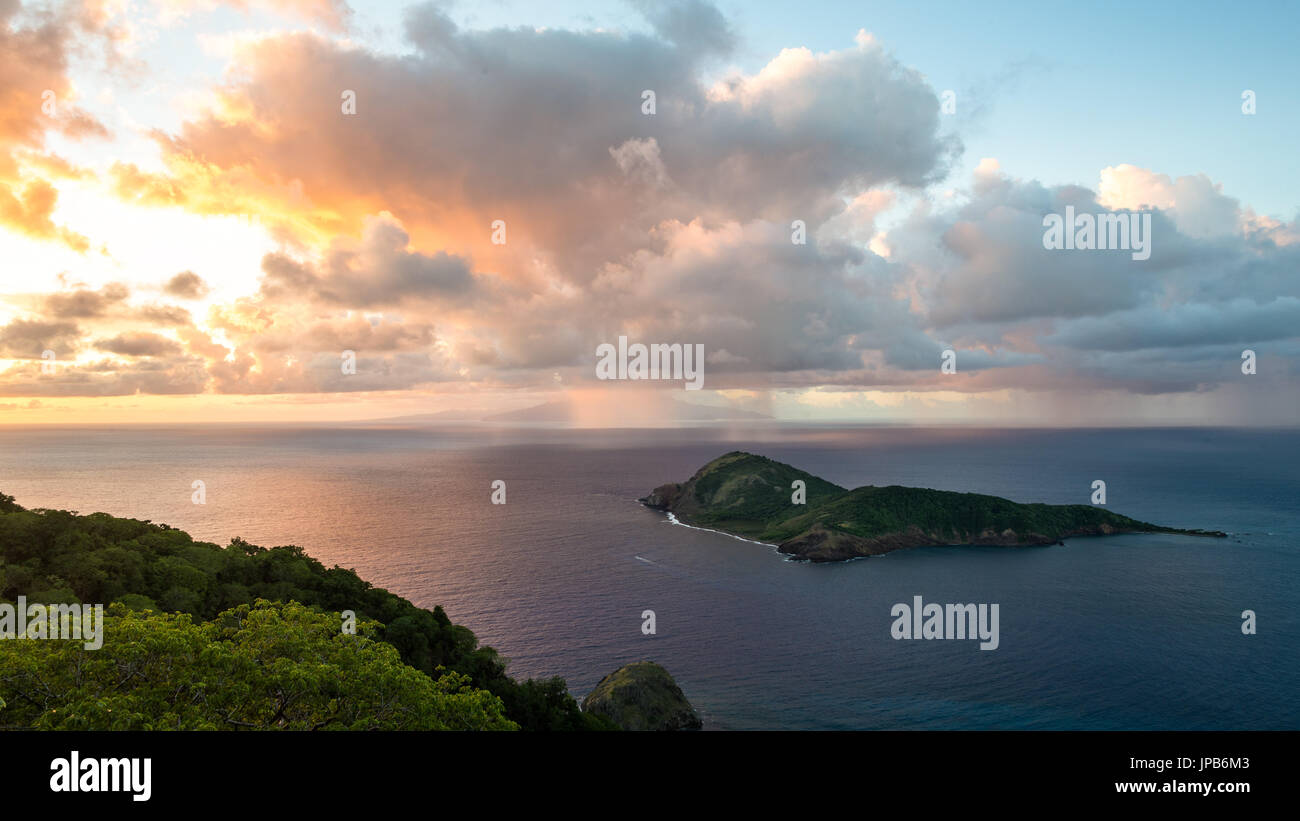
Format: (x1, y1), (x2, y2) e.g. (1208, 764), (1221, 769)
(0, 600), (517, 730)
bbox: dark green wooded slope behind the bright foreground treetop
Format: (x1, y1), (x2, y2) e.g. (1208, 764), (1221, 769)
(0, 495), (605, 730)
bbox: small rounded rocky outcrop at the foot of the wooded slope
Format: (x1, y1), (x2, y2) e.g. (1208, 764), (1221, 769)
(582, 661), (701, 730)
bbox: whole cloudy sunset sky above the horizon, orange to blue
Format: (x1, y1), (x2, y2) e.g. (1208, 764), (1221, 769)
(0, 0), (1300, 425)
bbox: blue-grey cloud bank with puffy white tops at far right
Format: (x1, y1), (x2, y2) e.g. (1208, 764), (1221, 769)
(883, 161), (1300, 394)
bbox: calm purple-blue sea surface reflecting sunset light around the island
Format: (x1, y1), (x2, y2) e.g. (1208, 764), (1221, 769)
(0, 426), (1300, 730)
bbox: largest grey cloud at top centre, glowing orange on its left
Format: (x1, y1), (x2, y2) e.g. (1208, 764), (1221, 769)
(113, 4), (959, 287)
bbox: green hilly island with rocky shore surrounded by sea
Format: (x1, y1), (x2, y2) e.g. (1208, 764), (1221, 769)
(640, 451), (1227, 561)
